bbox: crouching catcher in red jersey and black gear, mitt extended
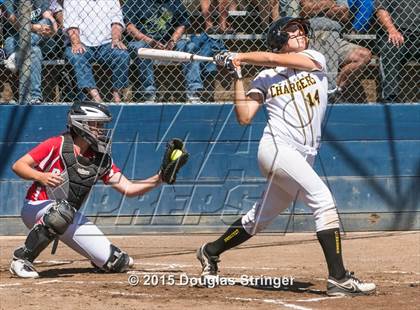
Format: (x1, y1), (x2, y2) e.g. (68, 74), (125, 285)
(10, 102), (188, 278)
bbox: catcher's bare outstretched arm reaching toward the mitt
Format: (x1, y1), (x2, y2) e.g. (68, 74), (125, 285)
(108, 172), (162, 197)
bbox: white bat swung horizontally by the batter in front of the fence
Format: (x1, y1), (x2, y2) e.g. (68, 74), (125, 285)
(137, 48), (214, 62)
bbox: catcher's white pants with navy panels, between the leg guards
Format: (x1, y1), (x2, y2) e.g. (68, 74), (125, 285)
(21, 200), (111, 267)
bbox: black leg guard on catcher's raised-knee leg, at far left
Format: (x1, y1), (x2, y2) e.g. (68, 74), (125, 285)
(14, 200), (76, 262)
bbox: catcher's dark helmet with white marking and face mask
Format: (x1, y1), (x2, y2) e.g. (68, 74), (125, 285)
(67, 101), (112, 153)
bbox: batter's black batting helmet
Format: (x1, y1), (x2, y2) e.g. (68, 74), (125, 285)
(267, 16), (312, 52)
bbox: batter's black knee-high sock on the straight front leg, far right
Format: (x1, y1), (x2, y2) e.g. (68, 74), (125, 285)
(316, 228), (346, 279)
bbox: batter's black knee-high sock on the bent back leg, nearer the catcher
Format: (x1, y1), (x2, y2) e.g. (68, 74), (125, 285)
(206, 218), (252, 256)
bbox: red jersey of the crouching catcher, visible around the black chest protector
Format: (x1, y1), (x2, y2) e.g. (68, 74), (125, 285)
(26, 136), (121, 200)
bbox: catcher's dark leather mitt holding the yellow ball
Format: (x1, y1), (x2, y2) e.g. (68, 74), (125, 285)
(159, 138), (190, 184)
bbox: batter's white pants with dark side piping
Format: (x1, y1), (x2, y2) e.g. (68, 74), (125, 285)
(242, 134), (339, 235)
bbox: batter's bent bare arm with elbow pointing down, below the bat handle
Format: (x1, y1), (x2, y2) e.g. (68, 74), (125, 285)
(234, 80), (263, 125)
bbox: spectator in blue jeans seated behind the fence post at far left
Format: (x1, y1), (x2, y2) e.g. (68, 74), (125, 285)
(4, 0), (57, 104)
